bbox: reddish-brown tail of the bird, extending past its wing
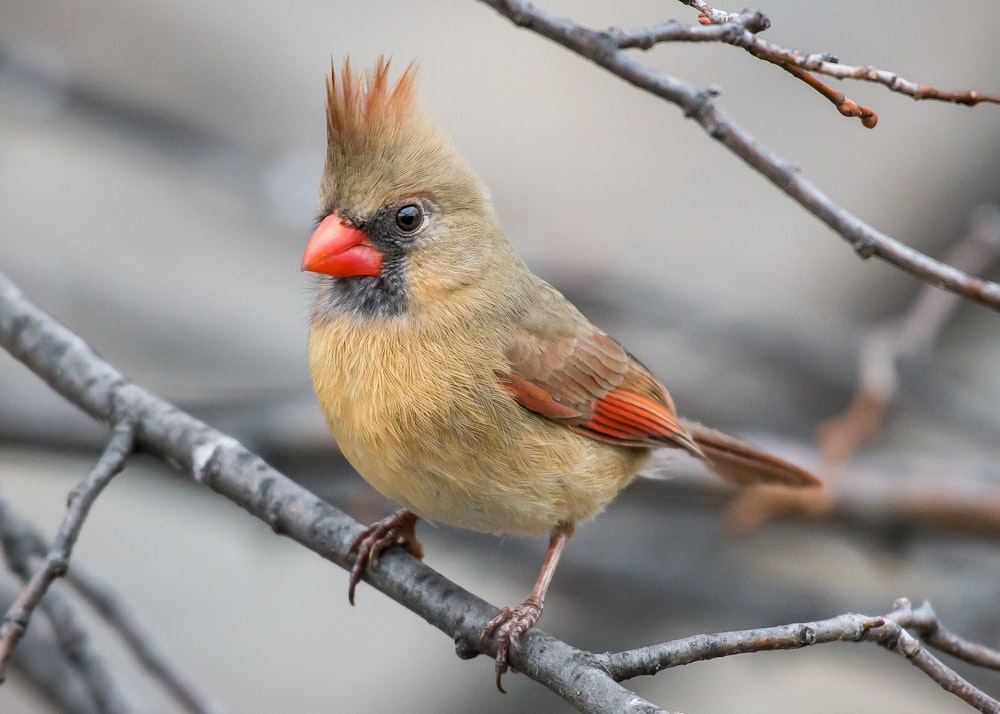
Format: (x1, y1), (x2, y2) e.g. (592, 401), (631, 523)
(684, 420), (823, 488)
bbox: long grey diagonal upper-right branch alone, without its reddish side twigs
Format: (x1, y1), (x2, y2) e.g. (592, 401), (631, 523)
(480, 0), (1000, 310)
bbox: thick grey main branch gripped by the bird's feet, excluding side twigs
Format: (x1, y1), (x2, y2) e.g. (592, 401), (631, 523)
(0, 273), (662, 714)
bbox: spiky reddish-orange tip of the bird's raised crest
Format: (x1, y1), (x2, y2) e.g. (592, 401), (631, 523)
(326, 56), (417, 144)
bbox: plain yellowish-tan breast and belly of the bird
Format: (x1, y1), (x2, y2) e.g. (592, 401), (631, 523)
(309, 317), (648, 534)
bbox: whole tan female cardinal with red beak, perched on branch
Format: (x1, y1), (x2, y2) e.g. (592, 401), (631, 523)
(302, 59), (818, 691)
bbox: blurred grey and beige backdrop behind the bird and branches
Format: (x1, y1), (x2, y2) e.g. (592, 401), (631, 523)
(0, 0), (1000, 714)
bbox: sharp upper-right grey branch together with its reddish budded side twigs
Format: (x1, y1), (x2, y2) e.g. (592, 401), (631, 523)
(480, 0), (1000, 310)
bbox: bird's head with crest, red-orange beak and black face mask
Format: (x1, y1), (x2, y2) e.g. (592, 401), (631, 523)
(302, 58), (509, 317)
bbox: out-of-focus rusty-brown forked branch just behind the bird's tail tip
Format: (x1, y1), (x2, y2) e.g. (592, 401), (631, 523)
(729, 205), (1000, 538)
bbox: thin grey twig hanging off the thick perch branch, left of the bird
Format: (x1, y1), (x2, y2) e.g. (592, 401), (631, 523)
(0, 421), (135, 682)
